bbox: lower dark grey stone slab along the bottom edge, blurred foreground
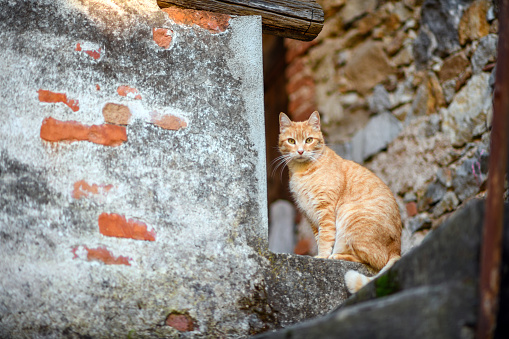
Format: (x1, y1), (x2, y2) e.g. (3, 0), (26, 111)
(254, 283), (477, 339)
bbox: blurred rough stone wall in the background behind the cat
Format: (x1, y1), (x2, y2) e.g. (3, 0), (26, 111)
(286, 0), (498, 255)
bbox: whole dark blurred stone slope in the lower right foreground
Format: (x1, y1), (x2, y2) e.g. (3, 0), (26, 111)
(255, 200), (509, 338)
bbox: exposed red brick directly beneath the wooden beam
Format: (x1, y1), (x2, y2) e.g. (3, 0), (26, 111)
(162, 7), (231, 33)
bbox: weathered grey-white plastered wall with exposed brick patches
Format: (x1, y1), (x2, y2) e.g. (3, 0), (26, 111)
(0, 0), (365, 338)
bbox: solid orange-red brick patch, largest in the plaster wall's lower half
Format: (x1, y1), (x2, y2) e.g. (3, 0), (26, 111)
(98, 213), (156, 241)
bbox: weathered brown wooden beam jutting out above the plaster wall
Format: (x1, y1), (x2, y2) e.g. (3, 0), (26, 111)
(157, 0), (324, 41)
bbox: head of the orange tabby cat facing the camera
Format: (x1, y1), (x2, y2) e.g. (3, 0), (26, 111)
(279, 111), (324, 163)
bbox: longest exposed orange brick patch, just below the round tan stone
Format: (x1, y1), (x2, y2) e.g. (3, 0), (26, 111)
(41, 117), (127, 146)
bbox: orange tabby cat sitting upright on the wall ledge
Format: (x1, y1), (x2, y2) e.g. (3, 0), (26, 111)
(279, 112), (401, 293)
